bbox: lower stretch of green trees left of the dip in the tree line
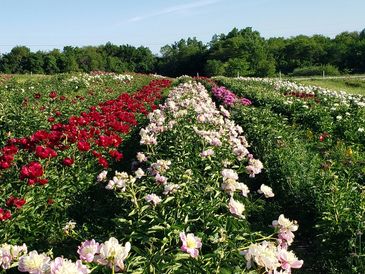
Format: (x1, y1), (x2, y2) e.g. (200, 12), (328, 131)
(0, 43), (156, 74)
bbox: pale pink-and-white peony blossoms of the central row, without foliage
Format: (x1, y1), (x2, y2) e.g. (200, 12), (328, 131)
(106, 82), (303, 273)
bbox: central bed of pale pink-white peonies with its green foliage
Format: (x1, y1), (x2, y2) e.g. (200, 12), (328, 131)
(98, 83), (303, 273)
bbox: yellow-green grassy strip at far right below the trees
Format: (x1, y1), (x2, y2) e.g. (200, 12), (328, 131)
(297, 76), (365, 95)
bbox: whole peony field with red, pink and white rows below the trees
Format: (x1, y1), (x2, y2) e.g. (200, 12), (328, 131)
(0, 72), (365, 274)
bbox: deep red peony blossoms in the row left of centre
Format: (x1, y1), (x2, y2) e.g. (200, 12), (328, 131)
(0, 79), (171, 220)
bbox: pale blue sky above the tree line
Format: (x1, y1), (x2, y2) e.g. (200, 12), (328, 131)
(0, 0), (365, 53)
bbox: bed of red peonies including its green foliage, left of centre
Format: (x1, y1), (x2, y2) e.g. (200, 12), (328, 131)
(0, 76), (170, 248)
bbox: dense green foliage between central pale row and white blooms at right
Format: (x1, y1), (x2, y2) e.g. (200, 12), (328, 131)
(208, 78), (365, 273)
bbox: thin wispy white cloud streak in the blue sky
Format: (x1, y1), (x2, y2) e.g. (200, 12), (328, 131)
(128, 0), (222, 22)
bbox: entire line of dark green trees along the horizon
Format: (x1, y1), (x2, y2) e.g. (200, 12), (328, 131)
(0, 27), (365, 76)
